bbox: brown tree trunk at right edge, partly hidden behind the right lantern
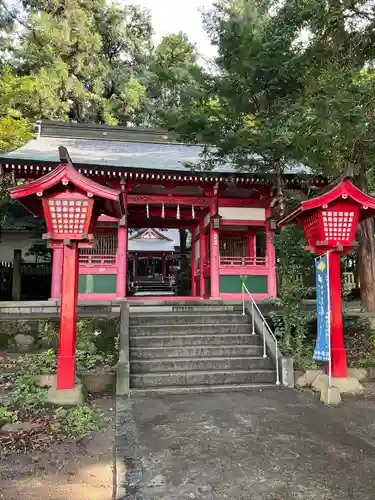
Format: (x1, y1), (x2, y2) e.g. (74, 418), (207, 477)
(357, 165), (375, 312)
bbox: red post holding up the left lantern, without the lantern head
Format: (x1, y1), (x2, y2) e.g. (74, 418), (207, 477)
(56, 241), (78, 389)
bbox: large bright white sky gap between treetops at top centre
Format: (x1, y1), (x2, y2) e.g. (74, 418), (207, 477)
(125, 0), (215, 58)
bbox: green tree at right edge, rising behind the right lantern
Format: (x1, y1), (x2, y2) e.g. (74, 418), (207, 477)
(288, 2), (375, 311)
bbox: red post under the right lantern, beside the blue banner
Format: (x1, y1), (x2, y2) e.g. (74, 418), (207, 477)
(328, 252), (348, 378)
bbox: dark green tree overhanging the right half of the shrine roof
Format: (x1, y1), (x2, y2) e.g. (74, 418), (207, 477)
(168, 0), (314, 213)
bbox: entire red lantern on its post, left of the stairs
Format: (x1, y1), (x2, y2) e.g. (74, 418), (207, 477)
(9, 147), (123, 403)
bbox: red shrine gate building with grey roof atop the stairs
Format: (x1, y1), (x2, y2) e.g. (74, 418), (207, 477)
(0, 121), (324, 300)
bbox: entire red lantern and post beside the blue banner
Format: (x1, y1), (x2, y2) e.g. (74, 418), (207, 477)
(279, 179), (375, 378)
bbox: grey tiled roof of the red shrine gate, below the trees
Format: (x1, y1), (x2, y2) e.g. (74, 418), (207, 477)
(0, 121), (309, 174)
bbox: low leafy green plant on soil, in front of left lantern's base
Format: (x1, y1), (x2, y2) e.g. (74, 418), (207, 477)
(52, 405), (99, 438)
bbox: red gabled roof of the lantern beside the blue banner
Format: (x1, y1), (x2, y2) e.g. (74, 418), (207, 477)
(279, 179), (375, 226)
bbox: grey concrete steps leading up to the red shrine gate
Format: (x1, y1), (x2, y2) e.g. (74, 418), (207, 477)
(130, 304), (276, 395)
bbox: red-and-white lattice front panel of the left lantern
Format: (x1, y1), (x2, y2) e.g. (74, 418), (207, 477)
(48, 199), (89, 234)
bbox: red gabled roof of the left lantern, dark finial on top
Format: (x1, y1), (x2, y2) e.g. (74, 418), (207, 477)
(9, 152), (124, 218)
